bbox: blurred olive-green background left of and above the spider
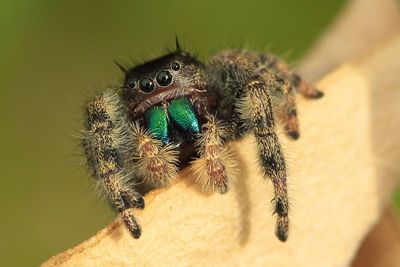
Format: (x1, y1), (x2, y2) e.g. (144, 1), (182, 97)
(0, 0), (398, 266)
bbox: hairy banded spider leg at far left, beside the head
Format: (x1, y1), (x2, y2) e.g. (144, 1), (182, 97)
(83, 91), (144, 238)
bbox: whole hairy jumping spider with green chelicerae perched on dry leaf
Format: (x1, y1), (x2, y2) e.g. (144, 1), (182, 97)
(83, 41), (322, 241)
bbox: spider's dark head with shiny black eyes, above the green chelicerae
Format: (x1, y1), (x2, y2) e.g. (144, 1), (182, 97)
(124, 44), (206, 115)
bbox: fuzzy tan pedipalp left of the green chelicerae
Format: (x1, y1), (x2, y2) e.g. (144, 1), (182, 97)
(130, 123), (178, 187)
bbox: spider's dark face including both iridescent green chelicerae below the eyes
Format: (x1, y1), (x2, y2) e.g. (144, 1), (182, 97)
(123, 49), (212, 144)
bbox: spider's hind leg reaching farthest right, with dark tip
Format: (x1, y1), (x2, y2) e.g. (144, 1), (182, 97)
(260, 53), (324, 99)
